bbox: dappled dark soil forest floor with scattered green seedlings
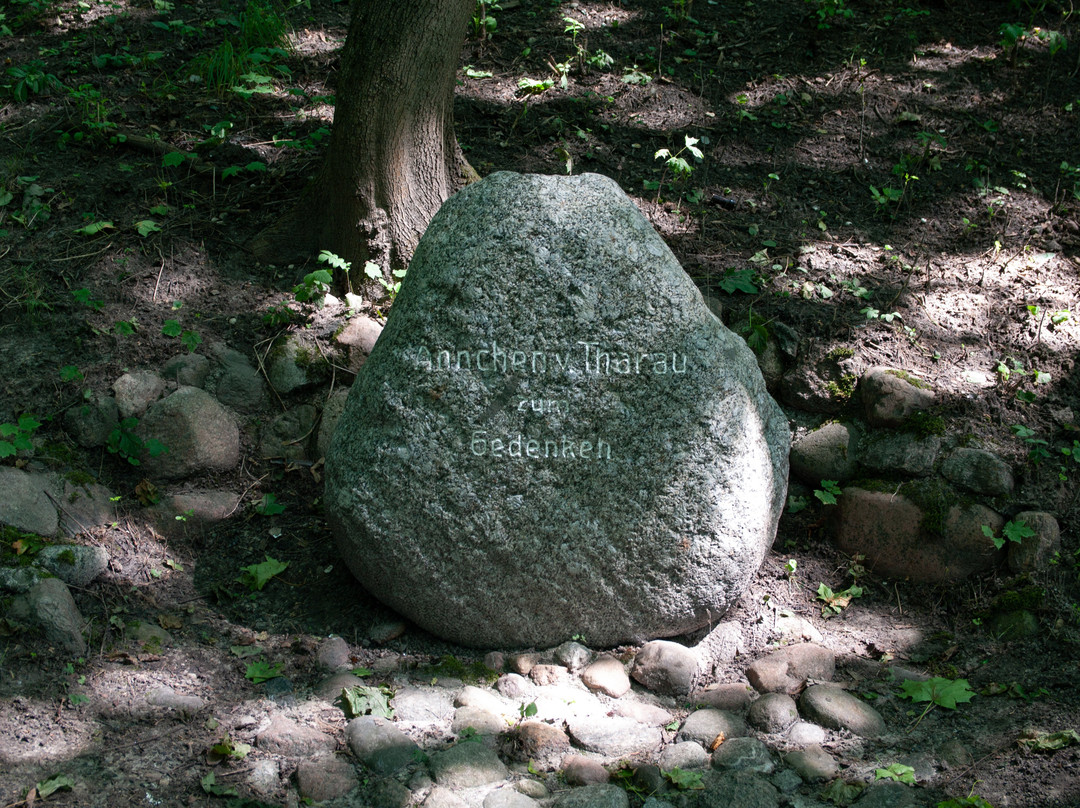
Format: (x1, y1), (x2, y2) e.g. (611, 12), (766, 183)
(0, 0), (1080, 808)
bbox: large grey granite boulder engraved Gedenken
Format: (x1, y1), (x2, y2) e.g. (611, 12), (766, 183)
(325, 172), (791, 647)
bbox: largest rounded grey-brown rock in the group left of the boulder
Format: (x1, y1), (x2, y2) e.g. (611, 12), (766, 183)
(136, 387), (240, 480)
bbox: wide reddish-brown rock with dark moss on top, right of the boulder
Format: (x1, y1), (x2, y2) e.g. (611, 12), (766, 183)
(833, 483), (1004, 583)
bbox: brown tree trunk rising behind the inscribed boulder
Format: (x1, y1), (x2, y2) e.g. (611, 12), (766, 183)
(253, 0), (476, 279)
